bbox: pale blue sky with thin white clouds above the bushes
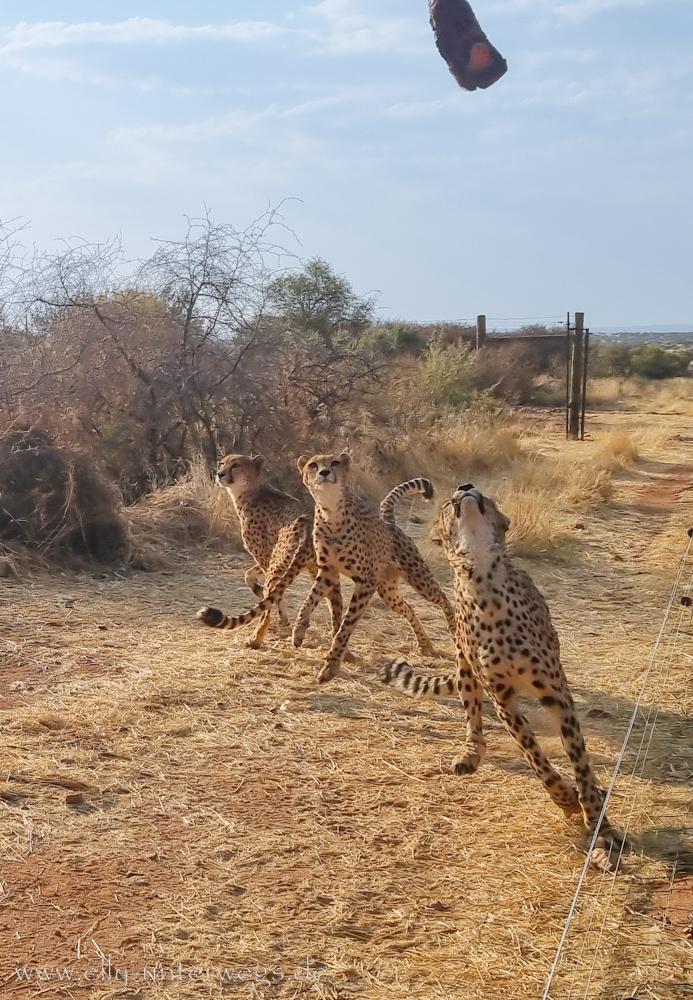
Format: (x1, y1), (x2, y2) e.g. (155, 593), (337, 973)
(0, 0), (693, 328)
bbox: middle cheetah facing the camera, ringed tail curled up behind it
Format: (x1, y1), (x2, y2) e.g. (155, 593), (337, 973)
(197, 454), (455, 682)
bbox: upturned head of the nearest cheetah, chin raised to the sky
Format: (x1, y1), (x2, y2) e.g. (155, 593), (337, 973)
(431, 483), (510, 555)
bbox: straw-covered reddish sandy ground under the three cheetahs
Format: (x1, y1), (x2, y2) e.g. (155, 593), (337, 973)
(0, 402), (693, 1000)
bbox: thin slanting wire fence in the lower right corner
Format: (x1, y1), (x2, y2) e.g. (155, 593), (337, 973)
(542, 529), (693, 1000)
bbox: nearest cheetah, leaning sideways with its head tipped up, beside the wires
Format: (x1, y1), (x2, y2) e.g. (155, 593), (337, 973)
(381, 484), (619, 843)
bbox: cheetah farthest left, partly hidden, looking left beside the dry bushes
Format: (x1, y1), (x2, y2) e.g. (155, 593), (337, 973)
(198, 455), (343, 649)
